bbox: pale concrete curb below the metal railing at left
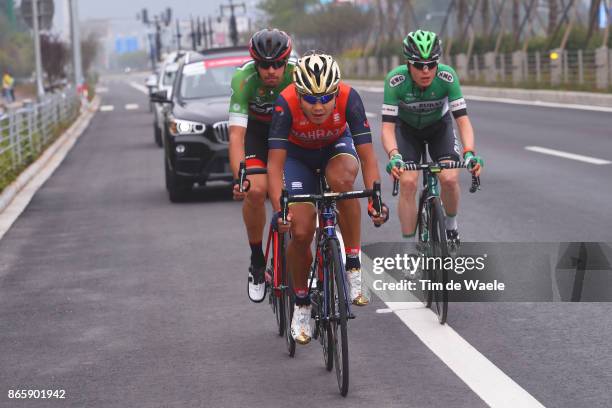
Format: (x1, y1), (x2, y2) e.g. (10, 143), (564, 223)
(0, 96), (100, 239)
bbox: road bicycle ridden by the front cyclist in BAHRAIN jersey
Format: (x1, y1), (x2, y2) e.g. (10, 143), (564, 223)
(281, 171), (382, 396)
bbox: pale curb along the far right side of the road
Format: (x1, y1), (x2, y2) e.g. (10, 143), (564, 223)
(347, 79), (612, 108)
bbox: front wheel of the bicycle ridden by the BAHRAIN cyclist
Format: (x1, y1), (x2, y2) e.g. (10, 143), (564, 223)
(327, 240), (349, 397)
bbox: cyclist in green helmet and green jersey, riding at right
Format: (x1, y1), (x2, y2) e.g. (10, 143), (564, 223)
(382, 30), (483, 244)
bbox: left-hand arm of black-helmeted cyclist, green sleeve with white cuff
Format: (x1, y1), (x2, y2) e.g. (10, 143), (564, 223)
(229, 69), (249, 179)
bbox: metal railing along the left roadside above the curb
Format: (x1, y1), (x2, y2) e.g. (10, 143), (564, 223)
(0, 90), (81, 189)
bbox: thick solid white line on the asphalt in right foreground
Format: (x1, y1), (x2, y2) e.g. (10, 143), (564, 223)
(361, 253), (544, 408)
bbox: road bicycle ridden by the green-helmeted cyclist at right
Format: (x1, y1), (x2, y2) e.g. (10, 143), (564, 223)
(392, 144), (480, 324)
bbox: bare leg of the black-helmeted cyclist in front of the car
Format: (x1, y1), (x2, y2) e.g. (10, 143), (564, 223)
(242, 174), (268, 244)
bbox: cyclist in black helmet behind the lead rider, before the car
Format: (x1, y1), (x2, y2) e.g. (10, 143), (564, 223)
(229, 29), (294, 302)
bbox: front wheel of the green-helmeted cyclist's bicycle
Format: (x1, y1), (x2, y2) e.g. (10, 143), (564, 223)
(430, 197), (448, 324)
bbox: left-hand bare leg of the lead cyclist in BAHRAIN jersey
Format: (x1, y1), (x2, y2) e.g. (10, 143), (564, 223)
(287, 203), (316, 289)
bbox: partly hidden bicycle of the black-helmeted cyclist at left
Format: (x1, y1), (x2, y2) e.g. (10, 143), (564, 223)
(238, 162), (295, 357)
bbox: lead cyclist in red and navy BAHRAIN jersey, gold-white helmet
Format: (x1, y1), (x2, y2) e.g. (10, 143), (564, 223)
(268, 51), (388, 344)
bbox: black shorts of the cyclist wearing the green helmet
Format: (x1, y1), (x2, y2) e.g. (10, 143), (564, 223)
(395, 113), (461, 163)
